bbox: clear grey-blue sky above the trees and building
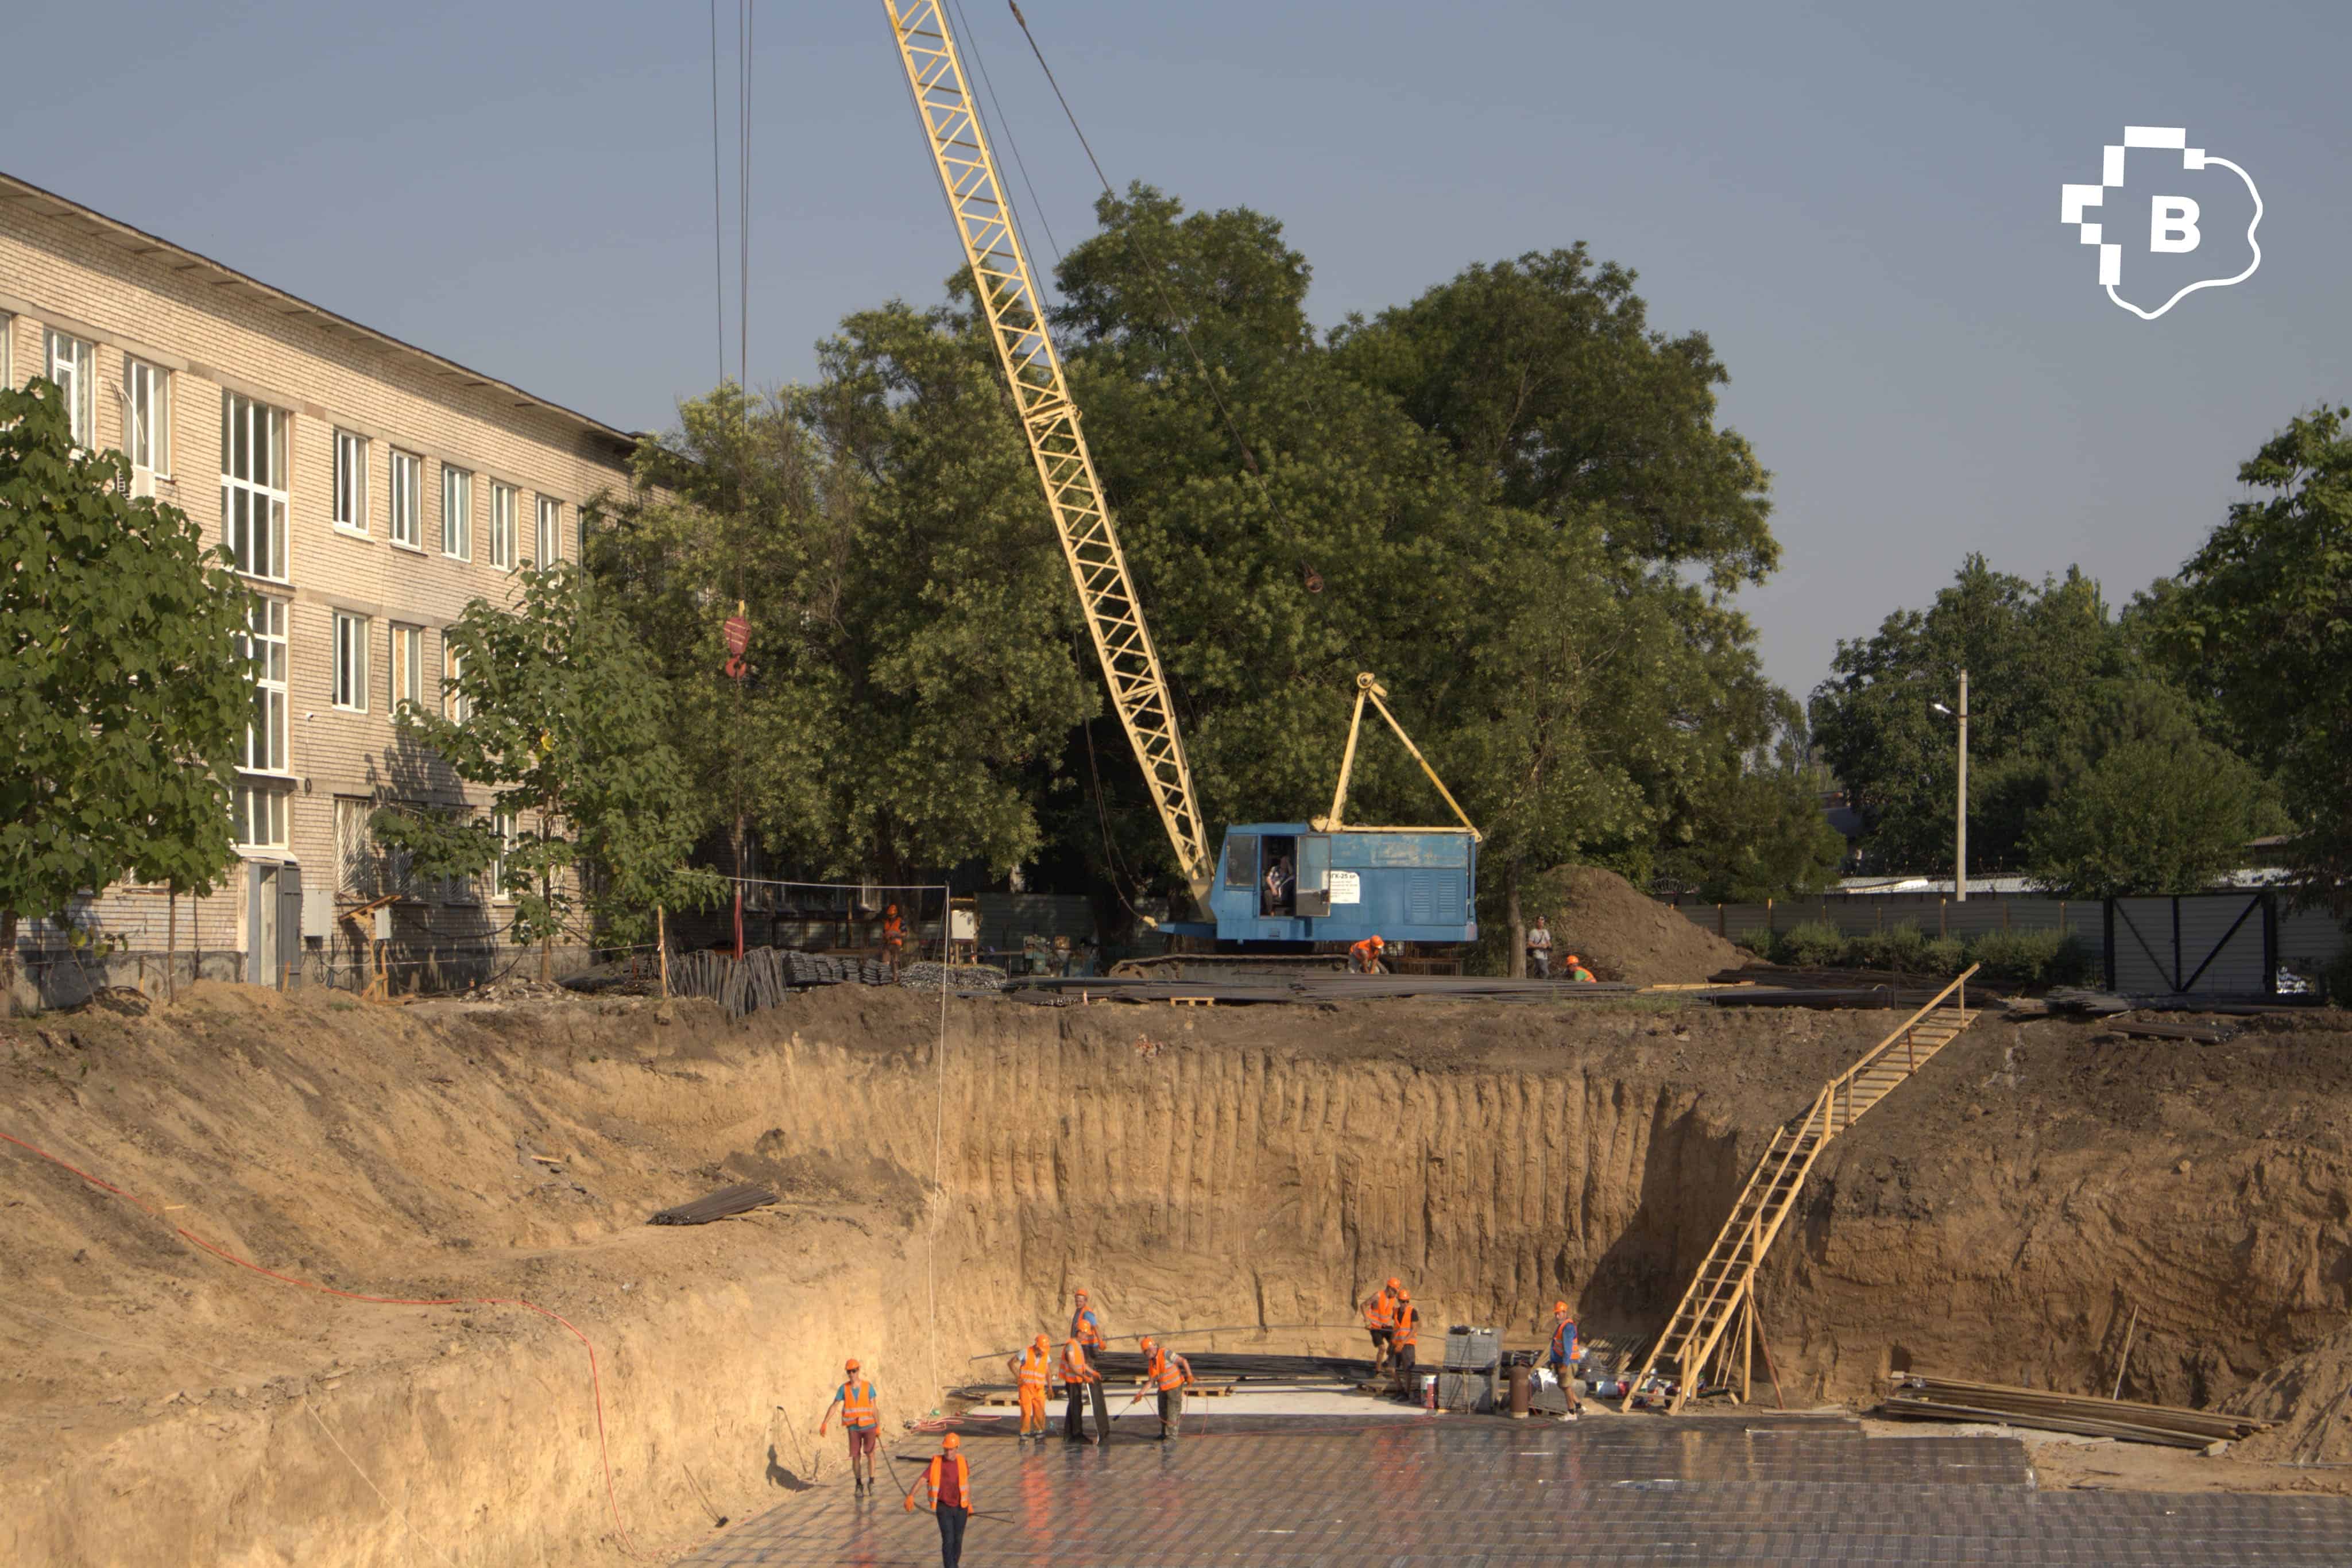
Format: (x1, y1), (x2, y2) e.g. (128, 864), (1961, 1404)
(0, 0), (2352, 694)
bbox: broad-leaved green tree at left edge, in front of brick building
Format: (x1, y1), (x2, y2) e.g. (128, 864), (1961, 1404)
(0, 381), (252, 994)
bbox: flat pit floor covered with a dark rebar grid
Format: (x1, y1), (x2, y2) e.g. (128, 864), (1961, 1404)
(689, 1413), (2352, 1568)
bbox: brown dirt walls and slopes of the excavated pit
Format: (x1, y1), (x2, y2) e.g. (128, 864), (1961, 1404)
(0, 988), (2352, 1566)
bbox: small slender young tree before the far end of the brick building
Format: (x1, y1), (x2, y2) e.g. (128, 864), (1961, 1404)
(374, 562), (725, 978)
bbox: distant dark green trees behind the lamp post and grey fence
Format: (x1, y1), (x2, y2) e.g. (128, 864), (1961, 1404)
(1813, 555), (2274, 898)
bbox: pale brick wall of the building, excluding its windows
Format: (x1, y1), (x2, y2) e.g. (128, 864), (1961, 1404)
(0, 183), (628, 992)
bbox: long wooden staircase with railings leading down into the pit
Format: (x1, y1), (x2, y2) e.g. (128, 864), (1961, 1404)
(1623, 964), (1976, 1415)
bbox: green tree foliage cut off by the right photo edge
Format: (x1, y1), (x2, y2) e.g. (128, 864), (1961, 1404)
(2145, 406), (2352, 912)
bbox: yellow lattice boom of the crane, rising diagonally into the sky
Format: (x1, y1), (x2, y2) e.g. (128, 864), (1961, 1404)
(882, 0), (1216, 907)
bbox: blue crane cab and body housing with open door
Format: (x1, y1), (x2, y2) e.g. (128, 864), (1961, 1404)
(1162, 823), (1477, 950)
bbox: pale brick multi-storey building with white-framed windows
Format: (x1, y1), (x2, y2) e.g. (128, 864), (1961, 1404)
(0, 174), (635, 1001)
